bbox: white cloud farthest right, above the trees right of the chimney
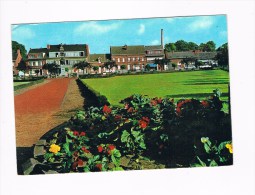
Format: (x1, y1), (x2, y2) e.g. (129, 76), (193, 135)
(187, 16), (214, 32)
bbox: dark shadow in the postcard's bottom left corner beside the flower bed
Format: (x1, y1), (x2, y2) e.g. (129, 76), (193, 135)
(16, 147), (33, 175)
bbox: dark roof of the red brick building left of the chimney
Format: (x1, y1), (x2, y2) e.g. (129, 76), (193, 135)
(110, 45), (145, 55)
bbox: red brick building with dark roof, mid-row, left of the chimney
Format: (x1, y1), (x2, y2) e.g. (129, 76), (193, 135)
(110, 45), (147, 72)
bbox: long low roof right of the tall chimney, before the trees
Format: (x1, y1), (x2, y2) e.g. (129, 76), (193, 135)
(166, 51), (217, 60)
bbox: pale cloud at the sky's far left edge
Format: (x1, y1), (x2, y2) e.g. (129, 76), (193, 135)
(12, 25), (35, 40)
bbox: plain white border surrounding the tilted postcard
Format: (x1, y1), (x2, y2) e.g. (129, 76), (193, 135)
(0, 1), (255, 195)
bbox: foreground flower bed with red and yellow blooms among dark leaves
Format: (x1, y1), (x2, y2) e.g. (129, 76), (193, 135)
(23, 91), (233, 173)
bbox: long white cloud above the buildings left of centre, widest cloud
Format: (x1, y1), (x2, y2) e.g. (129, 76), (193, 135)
(74, 21), (121, 34)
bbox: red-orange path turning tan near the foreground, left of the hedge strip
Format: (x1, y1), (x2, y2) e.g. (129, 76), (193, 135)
(14, 78), (71, 147)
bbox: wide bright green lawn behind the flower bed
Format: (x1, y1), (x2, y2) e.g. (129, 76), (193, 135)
(82, 70), (229, 105)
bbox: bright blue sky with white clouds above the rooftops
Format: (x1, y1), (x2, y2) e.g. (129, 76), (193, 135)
(12, 15), (227, 54)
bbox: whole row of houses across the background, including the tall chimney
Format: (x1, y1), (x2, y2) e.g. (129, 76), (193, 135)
(13, 29), (217, 75)
